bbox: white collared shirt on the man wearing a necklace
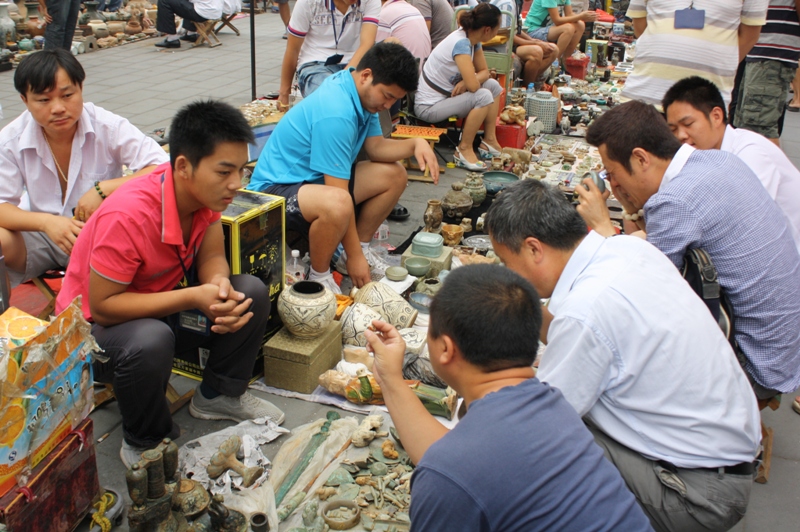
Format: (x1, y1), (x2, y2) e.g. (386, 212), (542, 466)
(0, 103), (169, 217)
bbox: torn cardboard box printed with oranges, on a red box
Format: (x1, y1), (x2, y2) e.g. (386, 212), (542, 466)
(0, 300), (100, 496)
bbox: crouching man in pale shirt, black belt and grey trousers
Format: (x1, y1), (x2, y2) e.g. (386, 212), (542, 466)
(486, 180), (761, 530)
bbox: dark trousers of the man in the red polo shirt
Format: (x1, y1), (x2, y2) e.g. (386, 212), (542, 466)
(92, 275), (270, 447)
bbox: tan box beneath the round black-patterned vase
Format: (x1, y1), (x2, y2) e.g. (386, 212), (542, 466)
(264, 321), (342, 393)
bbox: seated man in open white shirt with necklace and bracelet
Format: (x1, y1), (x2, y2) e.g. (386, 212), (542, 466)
(0, 48), (169, 286)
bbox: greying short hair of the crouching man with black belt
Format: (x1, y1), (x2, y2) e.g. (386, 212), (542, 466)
(486, 179), (589, 253)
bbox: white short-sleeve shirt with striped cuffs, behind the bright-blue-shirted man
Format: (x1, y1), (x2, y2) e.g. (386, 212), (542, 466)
(288, 0), (381, 67)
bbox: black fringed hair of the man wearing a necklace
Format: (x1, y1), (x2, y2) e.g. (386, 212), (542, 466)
(14, 48), (86, 96)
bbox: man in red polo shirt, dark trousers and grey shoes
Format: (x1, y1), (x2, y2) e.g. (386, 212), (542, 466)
(56, 101), (284, 467)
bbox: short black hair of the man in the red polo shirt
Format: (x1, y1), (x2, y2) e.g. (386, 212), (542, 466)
(169, 100), (255, 168)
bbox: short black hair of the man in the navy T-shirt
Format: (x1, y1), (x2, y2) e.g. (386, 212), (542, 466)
(429, 264), (542, 372)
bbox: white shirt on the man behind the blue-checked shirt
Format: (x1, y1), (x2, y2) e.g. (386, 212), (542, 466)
(720, 126), (800, 251)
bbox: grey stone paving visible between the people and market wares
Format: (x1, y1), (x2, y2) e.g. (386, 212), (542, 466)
(0, 10), (800, 532)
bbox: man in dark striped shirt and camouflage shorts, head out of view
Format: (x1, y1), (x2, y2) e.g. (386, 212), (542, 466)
(734, 0), (800, 146)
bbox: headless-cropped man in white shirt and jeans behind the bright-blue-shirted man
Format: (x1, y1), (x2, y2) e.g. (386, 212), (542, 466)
(278, 0), (381, 108)
